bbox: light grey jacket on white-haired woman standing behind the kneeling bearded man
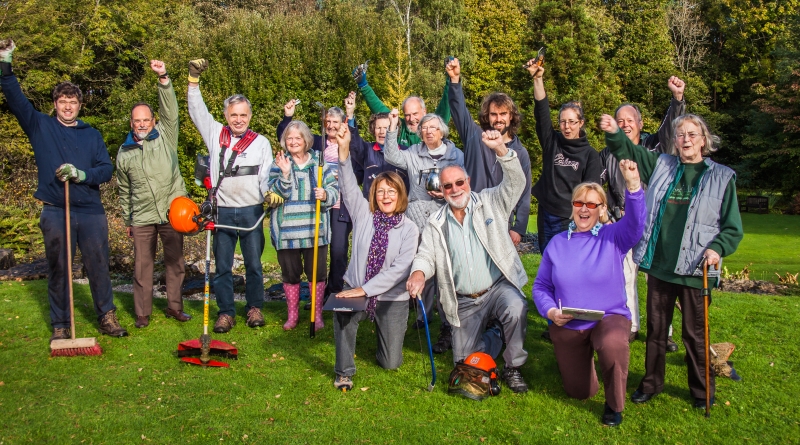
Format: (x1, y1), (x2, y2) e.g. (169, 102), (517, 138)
(383, 130), (466, 234)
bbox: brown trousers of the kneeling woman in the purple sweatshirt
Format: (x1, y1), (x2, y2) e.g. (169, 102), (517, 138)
(550, 315), (631, 412)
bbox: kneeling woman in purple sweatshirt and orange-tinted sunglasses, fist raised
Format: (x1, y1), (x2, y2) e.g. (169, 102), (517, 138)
(533, 161), (646, 426)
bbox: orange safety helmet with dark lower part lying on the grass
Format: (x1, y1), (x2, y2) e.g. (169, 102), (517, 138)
(447, 352), (500, 400)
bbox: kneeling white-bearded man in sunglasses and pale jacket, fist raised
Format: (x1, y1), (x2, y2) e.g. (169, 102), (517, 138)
(406, 130), (528, 393)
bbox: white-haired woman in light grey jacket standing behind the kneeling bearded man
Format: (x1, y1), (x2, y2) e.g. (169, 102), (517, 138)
(384, 108), (464, 346)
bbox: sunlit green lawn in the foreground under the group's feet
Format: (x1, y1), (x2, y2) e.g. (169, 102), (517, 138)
(0, 250), (800, 444)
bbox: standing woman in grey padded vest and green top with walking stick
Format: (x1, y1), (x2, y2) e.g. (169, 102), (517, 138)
(600, 114), (744, 408)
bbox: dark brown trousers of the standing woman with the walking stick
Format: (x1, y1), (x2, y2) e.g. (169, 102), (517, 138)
(639, 275), (716, 399)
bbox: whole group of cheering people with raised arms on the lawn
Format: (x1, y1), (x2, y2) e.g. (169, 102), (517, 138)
(0, 39), (742, 426)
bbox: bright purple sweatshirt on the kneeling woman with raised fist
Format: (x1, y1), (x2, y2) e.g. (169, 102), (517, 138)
(533, 189), (646, 330)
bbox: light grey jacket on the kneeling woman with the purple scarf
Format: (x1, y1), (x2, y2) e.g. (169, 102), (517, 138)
(339, 156), (419, 301)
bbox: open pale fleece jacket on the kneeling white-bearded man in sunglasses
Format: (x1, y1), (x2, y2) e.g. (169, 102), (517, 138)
(410, 149), (528, 326)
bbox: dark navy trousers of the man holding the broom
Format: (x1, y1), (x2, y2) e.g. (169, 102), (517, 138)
(39, 205), (117, 328)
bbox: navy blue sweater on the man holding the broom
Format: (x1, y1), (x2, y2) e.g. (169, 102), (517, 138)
(0, 75), (114, 214)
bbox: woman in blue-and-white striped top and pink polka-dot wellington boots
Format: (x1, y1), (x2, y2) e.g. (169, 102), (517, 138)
(268, 121), (339, 330)
